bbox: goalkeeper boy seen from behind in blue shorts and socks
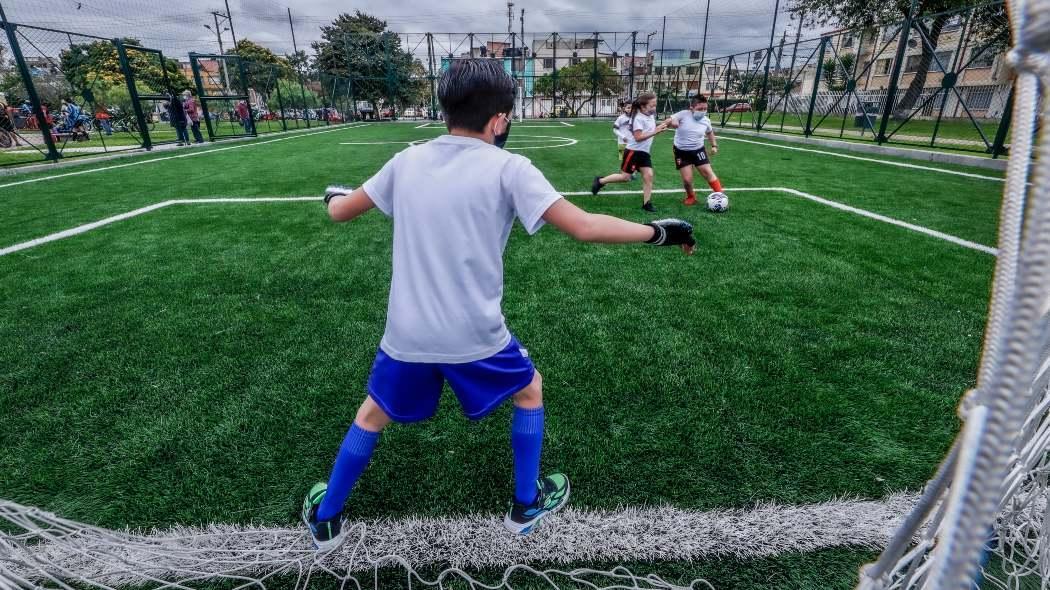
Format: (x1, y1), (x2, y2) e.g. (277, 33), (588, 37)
(302, 59), (696, 550)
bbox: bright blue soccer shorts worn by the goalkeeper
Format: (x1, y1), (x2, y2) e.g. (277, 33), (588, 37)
(369, 338), (536, 422)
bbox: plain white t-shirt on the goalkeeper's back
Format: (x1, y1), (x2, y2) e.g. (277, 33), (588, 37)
(363, 135), (562, 363)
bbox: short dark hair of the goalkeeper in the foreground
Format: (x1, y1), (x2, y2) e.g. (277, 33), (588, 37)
(438, 60), (515, 133)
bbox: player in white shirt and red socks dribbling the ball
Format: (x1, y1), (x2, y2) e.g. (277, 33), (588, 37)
(665, 94), (722, 205)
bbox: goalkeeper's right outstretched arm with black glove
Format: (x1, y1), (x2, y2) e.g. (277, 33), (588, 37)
(543, 198), (696, 254)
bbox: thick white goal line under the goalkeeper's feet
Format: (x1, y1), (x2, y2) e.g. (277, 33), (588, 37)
(8, 493), (918, 585)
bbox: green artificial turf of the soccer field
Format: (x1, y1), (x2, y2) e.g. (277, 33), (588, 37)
(0, 123), (1002, 588)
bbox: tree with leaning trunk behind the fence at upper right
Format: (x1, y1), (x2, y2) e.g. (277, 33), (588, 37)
(790, 0), (1009, 113)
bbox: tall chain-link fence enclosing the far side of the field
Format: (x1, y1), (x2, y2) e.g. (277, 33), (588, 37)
(0, 3), (1012, 165)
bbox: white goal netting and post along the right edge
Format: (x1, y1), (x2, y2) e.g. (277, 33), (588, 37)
(860, 0), (1050, 590)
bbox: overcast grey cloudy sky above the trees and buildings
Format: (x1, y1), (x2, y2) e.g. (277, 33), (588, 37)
(8, 0), (827, 63)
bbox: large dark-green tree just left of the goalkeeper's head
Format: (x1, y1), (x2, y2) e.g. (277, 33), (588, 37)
(311, 10), (425, 110)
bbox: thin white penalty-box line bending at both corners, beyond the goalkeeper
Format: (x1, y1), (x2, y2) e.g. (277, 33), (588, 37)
(0, 187), (999, 256)
